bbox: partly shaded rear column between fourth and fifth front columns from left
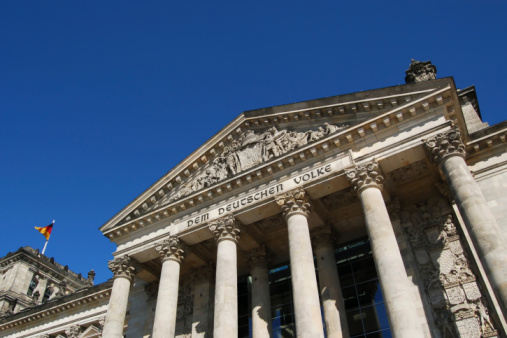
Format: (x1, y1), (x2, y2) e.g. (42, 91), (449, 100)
(312, 225), (349, 338)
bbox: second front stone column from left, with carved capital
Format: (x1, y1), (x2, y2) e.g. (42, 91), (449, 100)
(152, 236), (184, 338)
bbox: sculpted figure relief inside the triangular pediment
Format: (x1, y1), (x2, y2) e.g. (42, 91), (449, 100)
(155, 123), (349, 207)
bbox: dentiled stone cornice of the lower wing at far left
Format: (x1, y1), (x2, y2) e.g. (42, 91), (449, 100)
(0, 282), (112, 332)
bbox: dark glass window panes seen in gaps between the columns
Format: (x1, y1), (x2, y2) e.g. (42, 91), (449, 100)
(238, 239), (391, 338)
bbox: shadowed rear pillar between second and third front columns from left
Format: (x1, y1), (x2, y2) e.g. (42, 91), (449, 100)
(192, 266), (212, 338)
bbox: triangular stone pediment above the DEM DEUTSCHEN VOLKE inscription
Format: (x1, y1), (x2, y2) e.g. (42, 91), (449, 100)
(101, 79), (452, 234)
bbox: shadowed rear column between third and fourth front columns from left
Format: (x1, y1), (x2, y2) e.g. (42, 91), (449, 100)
(248, 247), (272, 338)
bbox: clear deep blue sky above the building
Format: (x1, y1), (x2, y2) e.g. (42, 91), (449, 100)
(0, 0), (507, 282)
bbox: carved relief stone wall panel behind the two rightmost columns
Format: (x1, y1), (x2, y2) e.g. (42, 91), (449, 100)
(402, 198), (497, 338)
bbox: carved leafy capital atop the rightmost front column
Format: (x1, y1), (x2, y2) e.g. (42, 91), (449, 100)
(423, 128), (466, 164)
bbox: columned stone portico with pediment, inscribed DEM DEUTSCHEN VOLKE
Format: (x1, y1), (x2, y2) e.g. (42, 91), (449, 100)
(0, 61), (507, 338)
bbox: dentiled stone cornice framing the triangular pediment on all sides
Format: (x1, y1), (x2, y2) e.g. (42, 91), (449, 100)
(101, 85), (455, 241)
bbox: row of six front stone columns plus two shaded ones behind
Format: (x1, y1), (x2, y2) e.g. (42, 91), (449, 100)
(103, 130), (507, 338)
